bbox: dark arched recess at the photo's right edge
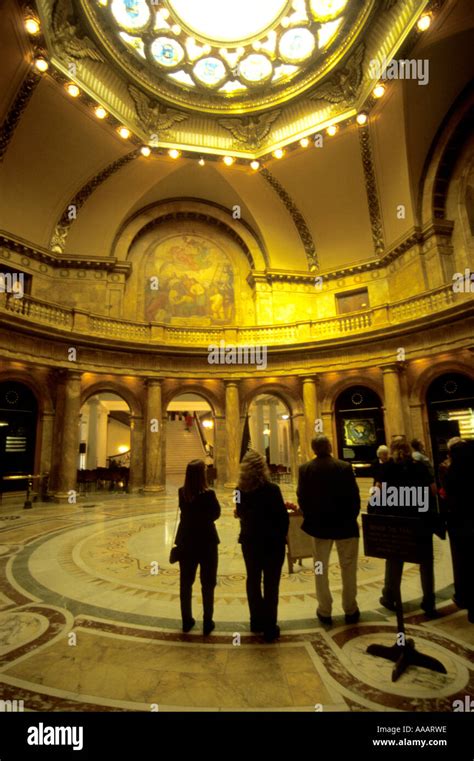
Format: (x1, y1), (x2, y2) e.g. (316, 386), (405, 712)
(426, 373), (474, 465)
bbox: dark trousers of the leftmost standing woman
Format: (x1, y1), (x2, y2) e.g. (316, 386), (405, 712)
(179, 544), (218, 623)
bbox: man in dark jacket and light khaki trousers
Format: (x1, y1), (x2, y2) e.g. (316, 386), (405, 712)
(298, 436), (360, 624)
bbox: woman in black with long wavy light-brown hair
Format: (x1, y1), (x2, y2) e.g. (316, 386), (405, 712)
(236, 450), (289, 642)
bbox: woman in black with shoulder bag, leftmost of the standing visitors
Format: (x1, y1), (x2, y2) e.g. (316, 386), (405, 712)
(175, 460), (221, 635)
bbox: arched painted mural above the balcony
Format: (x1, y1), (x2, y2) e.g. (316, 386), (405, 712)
(145, 234), (235, 325)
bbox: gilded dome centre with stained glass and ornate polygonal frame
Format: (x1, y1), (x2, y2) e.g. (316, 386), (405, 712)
(38, 0), (427, 158)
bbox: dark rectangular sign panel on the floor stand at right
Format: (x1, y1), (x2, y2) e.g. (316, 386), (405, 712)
(362, 515), (431, 563)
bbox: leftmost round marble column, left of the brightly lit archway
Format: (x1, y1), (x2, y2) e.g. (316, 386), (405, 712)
(54, 372), (81, 502)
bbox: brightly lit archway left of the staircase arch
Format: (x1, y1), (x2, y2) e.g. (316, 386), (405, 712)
(78, 392), (131, 491)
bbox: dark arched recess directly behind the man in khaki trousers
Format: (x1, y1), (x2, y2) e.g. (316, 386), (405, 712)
(335, 386), (385, 476)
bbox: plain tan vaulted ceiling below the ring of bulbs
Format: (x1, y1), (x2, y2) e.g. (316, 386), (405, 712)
(0, 0), (472, 271)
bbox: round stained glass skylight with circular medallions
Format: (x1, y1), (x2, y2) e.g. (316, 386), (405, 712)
(95, 0), (348, 98)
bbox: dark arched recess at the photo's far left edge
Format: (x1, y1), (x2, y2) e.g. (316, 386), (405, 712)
(0, 381), (38, 492)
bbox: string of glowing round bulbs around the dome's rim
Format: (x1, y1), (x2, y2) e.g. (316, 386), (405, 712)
(25, 13), (432, 172)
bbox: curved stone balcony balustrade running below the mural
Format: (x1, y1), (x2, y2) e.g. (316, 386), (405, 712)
(0, 284), (466, 348)
